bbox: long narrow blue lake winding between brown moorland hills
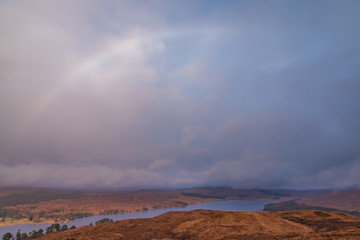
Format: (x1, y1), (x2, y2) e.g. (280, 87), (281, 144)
(0, 200), (274, 237)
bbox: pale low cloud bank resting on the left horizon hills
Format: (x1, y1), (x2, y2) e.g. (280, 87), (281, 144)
(0, 163), (165, 188)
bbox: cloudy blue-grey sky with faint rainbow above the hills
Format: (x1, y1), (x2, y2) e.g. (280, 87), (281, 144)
(0, 0), (360, 189)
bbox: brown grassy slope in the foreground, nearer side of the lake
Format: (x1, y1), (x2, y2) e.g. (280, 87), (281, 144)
(40, 210), (360, 240)
